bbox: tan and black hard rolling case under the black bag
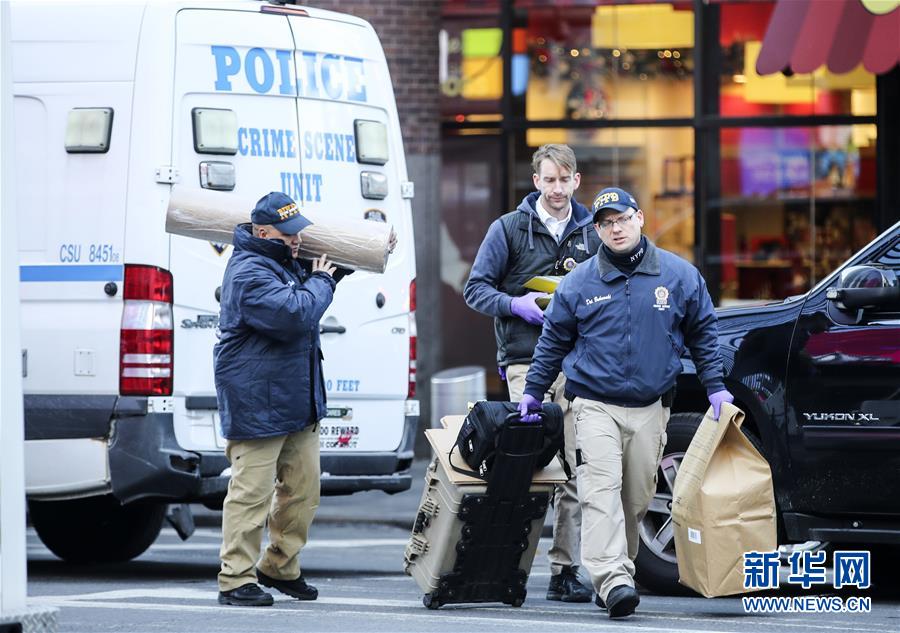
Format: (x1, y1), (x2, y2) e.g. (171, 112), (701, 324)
(404, 405), (565, 609)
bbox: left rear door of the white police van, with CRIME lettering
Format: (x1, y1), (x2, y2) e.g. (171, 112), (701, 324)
(170, 9), (299, 449)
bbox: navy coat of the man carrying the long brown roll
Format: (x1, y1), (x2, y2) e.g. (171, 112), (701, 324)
(213, 224), (335, 440)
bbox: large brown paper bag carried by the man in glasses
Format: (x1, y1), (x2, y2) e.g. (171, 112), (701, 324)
(672, 404), (778, 598)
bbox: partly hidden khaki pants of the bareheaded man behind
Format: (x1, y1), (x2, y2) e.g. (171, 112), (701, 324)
(506, 365), (581, 575)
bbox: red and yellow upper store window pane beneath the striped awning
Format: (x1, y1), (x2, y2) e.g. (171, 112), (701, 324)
(719, 0), (875, 116)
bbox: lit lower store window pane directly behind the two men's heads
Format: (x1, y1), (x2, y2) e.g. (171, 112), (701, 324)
(513, 127), (694, 261)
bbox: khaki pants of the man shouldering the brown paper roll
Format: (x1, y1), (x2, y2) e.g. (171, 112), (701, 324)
(219, 424), (319, 591)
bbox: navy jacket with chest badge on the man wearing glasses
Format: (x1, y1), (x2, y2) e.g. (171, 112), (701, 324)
(525, 240), (724, 407)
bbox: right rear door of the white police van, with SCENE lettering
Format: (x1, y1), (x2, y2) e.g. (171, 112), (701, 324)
(283, 12), (414, 454)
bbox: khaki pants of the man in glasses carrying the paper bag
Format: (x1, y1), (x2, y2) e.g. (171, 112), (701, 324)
(572, 398), (669, 600)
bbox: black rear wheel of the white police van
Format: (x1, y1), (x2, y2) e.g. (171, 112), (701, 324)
(28, 495), (167, 563)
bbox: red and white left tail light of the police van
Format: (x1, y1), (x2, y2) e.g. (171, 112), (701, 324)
(119, 264), (175, 396)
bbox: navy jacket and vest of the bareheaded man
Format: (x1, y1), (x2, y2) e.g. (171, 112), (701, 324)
(463, 191), (600, 367)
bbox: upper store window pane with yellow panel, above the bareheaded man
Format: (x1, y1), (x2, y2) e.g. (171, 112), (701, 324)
(512, 0), (694, 120)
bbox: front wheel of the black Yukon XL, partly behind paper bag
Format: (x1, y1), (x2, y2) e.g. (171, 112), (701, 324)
(634, 413), (762, 596)
